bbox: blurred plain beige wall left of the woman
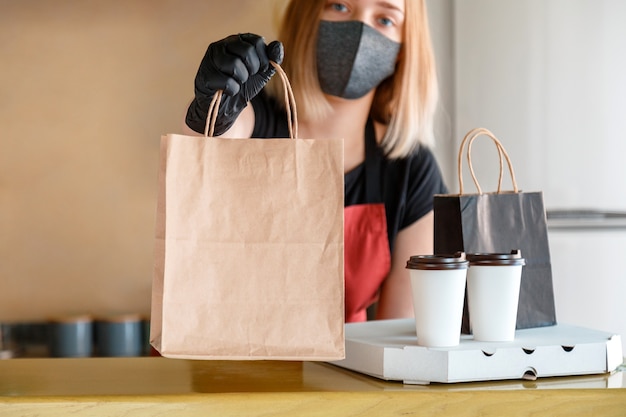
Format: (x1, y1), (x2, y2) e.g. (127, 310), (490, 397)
(0, 0), (280, 321)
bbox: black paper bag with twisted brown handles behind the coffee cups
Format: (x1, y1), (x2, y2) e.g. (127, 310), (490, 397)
(433, 128), (556, 333)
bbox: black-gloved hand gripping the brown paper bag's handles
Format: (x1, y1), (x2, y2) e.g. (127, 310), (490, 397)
(185, 33), (284, 136)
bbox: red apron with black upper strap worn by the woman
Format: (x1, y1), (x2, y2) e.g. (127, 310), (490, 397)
(344, 119), (391, 322)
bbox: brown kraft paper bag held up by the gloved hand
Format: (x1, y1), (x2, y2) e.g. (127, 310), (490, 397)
(150, 65), (345, 361)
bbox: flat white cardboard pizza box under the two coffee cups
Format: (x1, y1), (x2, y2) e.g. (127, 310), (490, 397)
(331, 319), (623, 384)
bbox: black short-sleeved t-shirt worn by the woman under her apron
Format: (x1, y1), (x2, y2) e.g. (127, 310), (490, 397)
(252, 92), (447, 253)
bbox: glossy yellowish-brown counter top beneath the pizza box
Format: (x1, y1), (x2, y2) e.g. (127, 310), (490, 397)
(0, 357), (626, 417)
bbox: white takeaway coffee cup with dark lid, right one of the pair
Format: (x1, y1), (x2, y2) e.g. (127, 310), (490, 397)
(467, 250), (526, 342)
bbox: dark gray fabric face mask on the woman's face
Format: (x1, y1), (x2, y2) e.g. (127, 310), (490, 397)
(317, 20), (401, 99)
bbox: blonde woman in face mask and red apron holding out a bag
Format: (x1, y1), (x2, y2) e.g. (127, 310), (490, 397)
(180, 0), (446, 322)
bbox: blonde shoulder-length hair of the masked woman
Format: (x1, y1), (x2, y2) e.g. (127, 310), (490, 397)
(269, 0), (438, 159)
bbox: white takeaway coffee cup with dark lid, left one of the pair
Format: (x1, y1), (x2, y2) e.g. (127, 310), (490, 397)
(406, 252), (469, 347)
